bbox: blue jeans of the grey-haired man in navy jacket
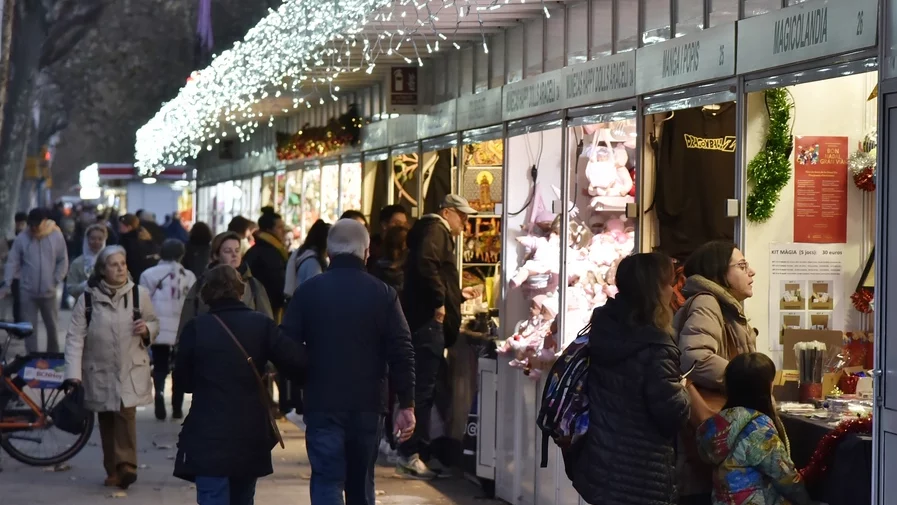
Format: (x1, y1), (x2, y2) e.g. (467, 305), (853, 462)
(305, 412), (383, 505)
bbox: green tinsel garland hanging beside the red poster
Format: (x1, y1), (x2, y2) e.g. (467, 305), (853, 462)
(747, 88), (794, 223)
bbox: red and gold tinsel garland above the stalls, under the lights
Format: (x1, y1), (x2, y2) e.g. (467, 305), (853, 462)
(277, 104), (364, 161)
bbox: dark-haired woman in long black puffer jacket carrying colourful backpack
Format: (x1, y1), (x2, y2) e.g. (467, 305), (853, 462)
(573, 253), (689, 505)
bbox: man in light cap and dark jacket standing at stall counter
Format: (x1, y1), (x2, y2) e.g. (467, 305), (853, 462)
(398, 195), (477, 479)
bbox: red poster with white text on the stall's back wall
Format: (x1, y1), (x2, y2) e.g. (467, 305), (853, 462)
(794, 137), (849, 244)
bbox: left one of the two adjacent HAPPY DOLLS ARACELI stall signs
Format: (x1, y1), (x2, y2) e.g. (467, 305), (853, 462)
(502, 69), (565, 121)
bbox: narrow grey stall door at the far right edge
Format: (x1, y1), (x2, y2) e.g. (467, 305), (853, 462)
(873, 85), (897, 505)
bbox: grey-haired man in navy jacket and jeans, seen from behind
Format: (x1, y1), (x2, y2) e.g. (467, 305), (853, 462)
(281, 219), (415, 505)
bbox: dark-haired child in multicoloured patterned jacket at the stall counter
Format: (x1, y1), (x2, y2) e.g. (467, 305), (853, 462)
(697, 352), (814, 505)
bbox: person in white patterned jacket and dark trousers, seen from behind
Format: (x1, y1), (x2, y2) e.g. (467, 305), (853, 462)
(140, 239), (196, 421)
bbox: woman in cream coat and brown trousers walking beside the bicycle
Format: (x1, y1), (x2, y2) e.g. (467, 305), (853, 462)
(65, 246), (159, 489)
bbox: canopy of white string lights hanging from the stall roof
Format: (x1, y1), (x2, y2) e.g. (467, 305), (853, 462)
(135, 0), (551, 175)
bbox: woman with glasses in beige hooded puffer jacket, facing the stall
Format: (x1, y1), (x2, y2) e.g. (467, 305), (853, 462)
(673, 241), (757, 505)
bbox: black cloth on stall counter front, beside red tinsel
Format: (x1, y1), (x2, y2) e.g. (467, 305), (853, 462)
(780, 414), (872, 505)
